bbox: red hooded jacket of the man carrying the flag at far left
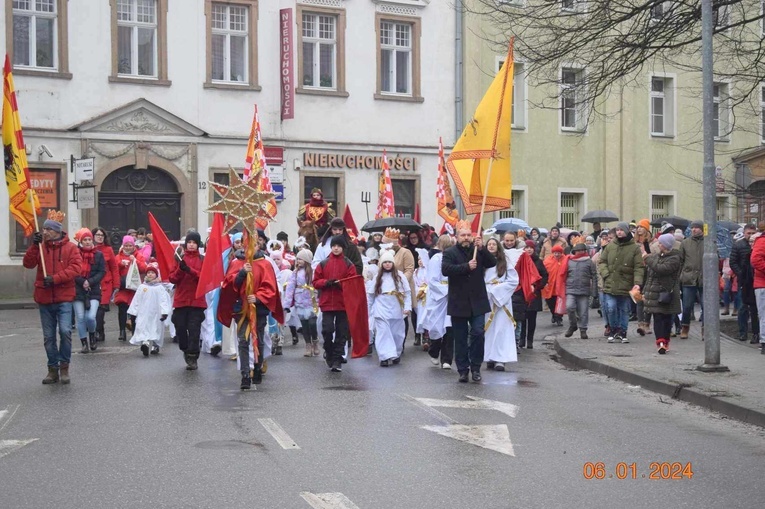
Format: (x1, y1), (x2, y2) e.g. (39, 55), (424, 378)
(23, 233), (82, 304)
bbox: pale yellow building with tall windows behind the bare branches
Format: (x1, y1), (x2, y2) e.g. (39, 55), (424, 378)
(462, 2), (765, 230)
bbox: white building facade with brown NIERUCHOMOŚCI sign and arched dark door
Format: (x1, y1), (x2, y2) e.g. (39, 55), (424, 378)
(0, 0), (456, 296)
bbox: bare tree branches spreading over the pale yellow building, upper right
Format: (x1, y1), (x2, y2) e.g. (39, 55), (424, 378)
(462, 0), (765, 137)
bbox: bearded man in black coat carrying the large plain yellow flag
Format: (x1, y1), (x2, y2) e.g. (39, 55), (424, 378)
(441, 221), (497, 383)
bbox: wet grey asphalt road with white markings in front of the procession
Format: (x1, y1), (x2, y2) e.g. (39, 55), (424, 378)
(0, 310), (765, 509)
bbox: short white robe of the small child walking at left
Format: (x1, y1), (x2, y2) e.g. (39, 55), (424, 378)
(128, 283), (173, 346)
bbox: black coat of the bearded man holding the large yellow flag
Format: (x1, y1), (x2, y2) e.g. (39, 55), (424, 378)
(441, 245), (497, 318)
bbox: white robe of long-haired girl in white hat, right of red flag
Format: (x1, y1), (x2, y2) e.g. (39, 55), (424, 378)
(367, 271), (412, 361)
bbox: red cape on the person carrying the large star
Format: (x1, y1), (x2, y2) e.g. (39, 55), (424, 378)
(217, 258), (284, 327)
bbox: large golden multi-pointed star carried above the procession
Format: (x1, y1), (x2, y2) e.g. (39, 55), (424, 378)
(207, 166), (276, 233)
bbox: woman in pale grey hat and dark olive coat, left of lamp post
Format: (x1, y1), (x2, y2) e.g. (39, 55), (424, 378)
(643, 233), (683, 354)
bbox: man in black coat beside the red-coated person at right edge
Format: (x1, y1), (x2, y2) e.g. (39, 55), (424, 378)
(728, 224), (760, 343)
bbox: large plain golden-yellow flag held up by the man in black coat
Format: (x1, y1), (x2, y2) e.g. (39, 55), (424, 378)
(446, 41), (513, 214)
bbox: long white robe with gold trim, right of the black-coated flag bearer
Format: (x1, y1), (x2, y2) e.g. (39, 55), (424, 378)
(483, 266), (518, 362)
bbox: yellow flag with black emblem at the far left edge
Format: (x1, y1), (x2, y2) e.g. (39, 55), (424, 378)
(2, 55), (42, 237)
